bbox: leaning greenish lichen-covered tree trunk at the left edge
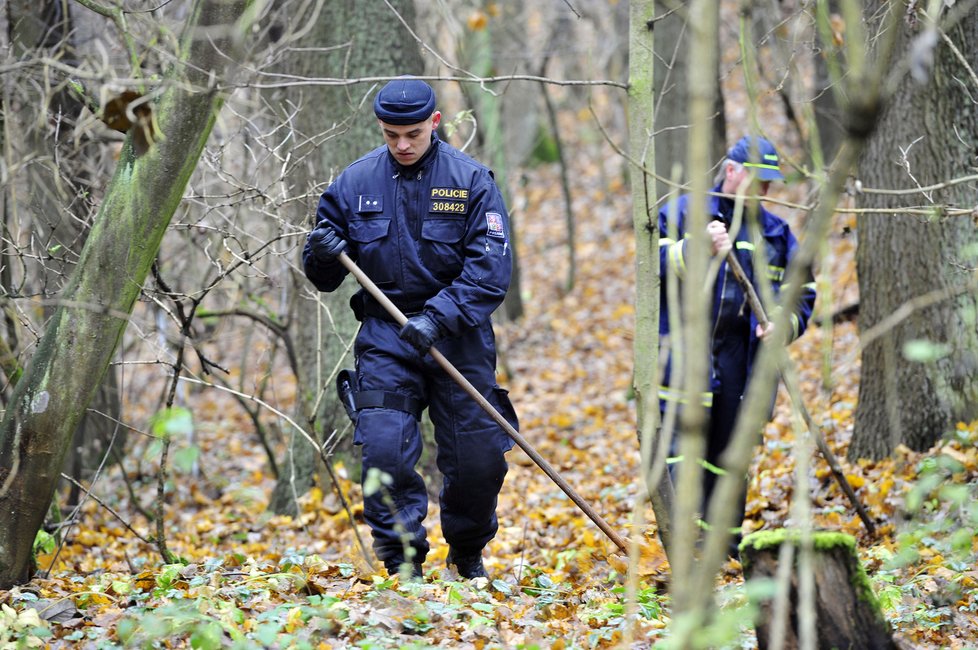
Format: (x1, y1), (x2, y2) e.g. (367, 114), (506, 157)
(0, 0), (252, 589)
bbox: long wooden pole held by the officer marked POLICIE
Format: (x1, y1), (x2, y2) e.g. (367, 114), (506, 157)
(338, 252), (628, 553)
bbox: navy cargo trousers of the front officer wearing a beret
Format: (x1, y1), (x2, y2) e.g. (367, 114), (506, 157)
(354, 317), (518, 562)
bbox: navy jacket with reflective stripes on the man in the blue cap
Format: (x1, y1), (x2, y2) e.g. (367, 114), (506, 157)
(659, 186), (815, 408)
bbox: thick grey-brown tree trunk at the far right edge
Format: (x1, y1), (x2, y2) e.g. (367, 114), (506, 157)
(849, 7), (978, 459)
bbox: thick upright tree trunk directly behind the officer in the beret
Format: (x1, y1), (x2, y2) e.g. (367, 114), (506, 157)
(269, 0), (424, 514)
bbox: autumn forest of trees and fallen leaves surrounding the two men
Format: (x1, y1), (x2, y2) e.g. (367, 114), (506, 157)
(0, 0), (978, 647)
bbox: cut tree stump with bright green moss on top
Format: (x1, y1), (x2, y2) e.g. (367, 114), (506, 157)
(741, 530), (897, 650)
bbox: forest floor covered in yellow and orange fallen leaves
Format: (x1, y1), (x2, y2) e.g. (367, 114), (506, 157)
(0, 129), (978, 648)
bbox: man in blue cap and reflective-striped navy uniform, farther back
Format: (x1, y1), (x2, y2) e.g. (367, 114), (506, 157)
(659, 136), (815, 556)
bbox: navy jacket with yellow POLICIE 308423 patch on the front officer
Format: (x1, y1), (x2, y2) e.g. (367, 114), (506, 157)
(302, 134), (512, 335)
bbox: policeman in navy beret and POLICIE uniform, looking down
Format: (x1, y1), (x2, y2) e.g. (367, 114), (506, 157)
(303, 77), (518, 578)
